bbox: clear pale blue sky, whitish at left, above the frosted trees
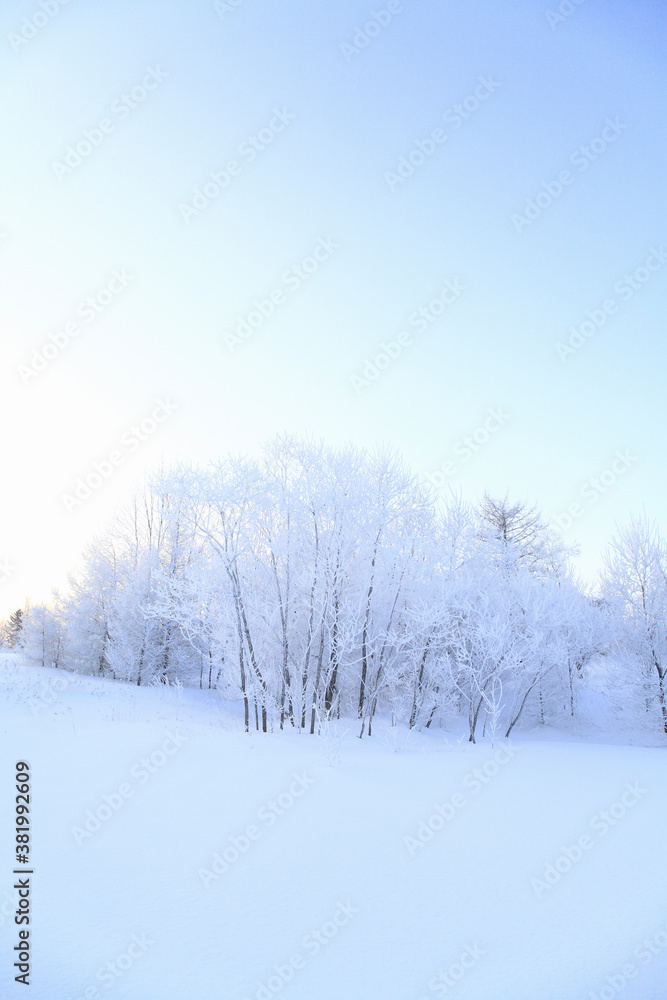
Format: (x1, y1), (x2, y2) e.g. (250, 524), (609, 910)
(0, 0), (667, 615)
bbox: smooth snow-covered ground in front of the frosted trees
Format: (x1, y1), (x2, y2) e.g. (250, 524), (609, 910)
(0, 655), (667, 1000)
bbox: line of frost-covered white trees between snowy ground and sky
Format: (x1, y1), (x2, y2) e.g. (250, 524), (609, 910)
(2, 436), (667, 742)
